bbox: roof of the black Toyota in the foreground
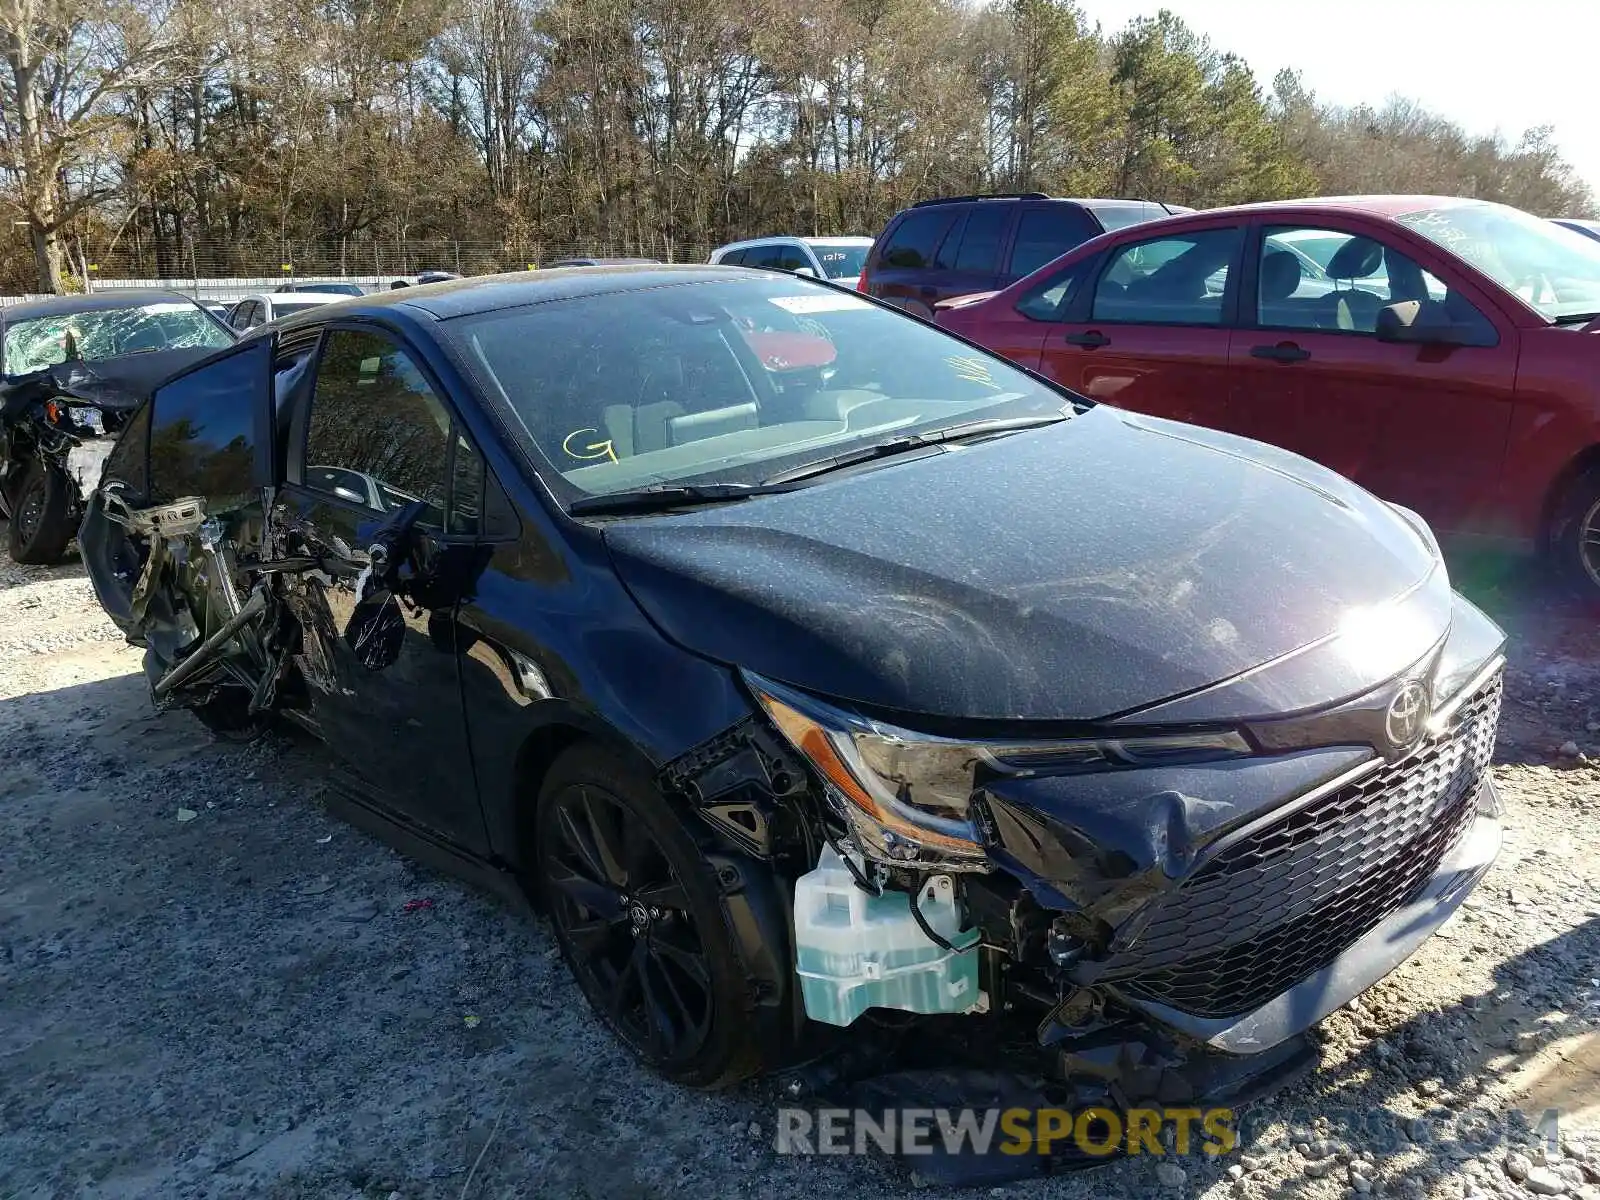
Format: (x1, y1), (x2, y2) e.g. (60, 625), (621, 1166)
(282, 264), (768, 328)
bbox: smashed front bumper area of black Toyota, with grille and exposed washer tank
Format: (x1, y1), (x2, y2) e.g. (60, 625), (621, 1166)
(662, 630), (1504, 1107)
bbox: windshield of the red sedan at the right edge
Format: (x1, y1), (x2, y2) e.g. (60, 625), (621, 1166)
(1398, 205), (1600, 320)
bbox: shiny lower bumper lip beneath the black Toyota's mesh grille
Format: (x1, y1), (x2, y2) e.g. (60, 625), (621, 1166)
(1122, 778), (1501, 1054)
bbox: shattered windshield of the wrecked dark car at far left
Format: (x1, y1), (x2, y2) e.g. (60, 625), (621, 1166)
(3, 301), (234, 374)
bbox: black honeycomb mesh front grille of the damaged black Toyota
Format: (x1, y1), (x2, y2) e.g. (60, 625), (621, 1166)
(1106, 672), (1501, 1018)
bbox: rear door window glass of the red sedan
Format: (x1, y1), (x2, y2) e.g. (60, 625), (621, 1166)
(1093, 229), (1242, 325)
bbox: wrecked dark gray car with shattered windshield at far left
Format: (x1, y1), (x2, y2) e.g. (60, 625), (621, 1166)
(0, 291), (234, 563)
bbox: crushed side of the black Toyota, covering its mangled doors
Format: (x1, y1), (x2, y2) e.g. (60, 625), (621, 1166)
(80, 326), (488, 853)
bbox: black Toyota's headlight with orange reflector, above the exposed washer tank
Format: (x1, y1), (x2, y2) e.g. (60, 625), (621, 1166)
(744, 672), (1250, 870)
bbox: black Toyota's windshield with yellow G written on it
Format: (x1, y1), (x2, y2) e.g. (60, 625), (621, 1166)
(445, 274), (1072, 502)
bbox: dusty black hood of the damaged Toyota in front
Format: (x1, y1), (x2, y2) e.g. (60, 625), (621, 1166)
(605, 405), (1450, 723)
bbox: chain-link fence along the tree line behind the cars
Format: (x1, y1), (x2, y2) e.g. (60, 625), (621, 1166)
(0, 238), (712, 306)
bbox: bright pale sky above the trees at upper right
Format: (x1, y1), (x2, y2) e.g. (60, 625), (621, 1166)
(1078, 0), (1600, 195)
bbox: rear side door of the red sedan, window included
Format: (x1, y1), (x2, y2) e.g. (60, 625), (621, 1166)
(1040, 226), (1245, 429)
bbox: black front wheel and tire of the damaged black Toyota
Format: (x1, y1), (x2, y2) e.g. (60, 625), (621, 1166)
(534, 742), (762, 1090)
